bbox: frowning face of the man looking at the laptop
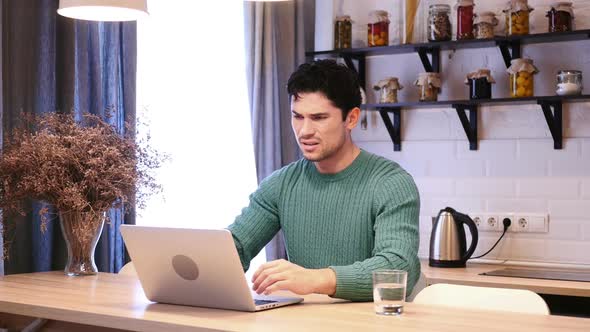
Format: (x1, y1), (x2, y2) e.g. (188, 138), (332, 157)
(291, 92), (354, 162)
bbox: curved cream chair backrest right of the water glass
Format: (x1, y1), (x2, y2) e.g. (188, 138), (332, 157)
(414, 284), (549, 315)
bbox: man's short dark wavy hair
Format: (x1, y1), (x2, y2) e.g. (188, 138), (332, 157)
(287, 60), (361, 120)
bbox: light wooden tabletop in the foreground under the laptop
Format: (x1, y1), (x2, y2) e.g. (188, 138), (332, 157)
(0, 272), (590, 332)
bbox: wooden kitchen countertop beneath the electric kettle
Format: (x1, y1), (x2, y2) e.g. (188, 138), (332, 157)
(422, 260), (590, 296)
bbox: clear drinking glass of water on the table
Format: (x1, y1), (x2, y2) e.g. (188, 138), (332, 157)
(373, 270), (408, 315)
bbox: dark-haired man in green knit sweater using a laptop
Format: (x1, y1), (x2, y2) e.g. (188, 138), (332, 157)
(229, 60), (420, 301)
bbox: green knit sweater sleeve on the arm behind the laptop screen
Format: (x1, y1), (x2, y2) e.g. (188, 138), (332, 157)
(228, 171), (281, 271)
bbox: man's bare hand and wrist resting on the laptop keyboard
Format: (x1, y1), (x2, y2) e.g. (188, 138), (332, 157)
(252, 259), (336, 295)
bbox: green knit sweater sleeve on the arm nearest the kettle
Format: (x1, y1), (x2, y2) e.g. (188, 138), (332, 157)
(330, 172), (420, 301)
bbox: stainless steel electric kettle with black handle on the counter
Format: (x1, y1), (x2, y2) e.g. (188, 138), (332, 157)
(429, 207), (478, 267)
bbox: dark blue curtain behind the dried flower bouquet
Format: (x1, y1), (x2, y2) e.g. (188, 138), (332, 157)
(0, 0), (137, 274)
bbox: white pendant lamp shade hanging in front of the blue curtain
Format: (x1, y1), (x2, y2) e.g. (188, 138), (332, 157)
(57, 0), (148, 22)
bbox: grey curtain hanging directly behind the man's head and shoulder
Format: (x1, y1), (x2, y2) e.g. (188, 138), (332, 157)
(244, 0), (315, 260)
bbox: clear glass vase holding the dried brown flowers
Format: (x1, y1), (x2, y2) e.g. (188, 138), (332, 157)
(59, 211), (106, 276)
